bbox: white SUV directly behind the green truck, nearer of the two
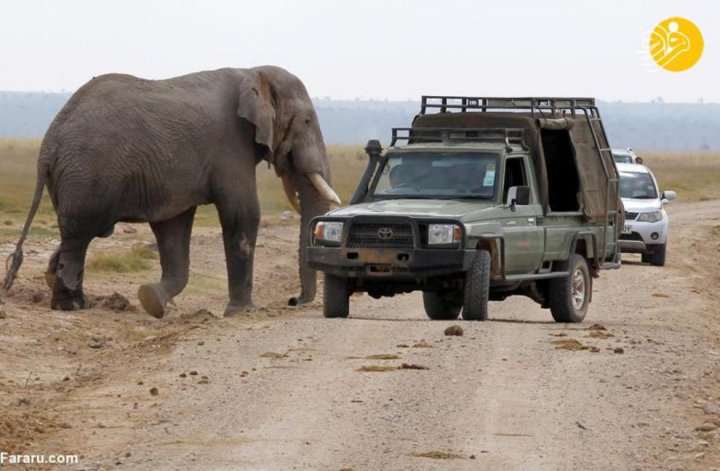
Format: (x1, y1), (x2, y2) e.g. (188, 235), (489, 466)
(617, 164), (676, 267)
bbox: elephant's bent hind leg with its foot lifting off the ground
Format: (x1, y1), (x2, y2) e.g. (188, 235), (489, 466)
(138, 207), (195, 319)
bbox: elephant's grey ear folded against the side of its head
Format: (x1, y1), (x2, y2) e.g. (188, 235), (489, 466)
(237, 73), (277, 163)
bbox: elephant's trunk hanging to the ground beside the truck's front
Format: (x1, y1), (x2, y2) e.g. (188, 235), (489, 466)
(288, 174), (334, 306)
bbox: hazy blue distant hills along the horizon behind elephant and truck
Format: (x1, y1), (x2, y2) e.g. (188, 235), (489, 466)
(0, 92), (720, 150)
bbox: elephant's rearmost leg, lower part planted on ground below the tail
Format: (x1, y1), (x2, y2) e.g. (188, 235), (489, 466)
(49, 238), (91, 311)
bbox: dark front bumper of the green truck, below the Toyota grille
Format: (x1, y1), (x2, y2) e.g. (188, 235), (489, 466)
(305, 246), (476, 280)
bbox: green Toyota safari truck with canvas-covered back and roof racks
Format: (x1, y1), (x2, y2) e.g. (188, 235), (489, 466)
(305, 96), (623, 322)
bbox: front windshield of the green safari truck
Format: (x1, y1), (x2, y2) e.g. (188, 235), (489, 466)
(370, 152), (498, 199)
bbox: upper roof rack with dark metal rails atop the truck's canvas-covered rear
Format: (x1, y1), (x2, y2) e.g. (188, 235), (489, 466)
(420, 95), (597, 116)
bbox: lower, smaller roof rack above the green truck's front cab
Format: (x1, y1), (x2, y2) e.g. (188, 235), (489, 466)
(390, 128), (528, 149)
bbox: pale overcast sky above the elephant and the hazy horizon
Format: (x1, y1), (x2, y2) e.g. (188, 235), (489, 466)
(0, 0), (720, 102)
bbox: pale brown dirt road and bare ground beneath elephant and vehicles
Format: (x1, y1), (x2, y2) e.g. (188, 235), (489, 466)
(0, 202), (720, 471)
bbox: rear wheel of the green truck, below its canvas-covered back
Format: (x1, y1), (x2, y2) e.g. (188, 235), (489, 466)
(548, 254), (592, 323)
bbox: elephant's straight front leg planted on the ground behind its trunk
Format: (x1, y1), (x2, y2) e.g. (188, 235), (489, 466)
(218, 197), (260, 317)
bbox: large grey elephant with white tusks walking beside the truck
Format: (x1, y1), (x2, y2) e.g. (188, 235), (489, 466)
(4, 66), (340, 318)
